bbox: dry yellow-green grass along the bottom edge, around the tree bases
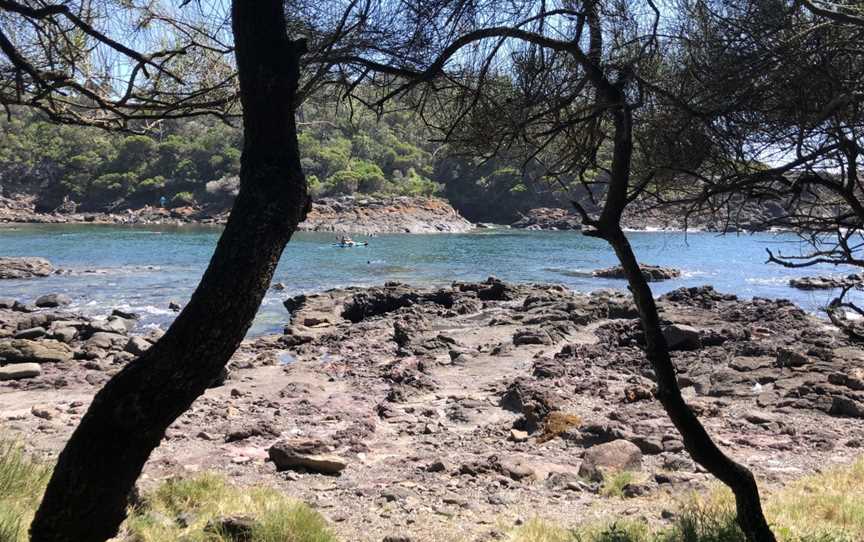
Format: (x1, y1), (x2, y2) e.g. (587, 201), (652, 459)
(0, 441), (864, 542)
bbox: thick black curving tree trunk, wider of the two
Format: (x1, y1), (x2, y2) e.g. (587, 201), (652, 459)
(30, 0), (309, 542)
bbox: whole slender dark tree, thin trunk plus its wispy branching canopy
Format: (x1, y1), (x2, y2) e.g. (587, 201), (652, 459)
(342, 0), (774, 541)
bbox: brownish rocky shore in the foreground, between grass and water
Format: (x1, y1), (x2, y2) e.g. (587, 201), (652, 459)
(0, 279), (864, 542)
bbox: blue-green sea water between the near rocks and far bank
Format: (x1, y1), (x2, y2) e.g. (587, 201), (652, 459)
(0, 225), (852, 334)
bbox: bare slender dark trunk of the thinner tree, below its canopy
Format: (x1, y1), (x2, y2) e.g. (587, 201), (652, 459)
(586, 106), (776, 542)
